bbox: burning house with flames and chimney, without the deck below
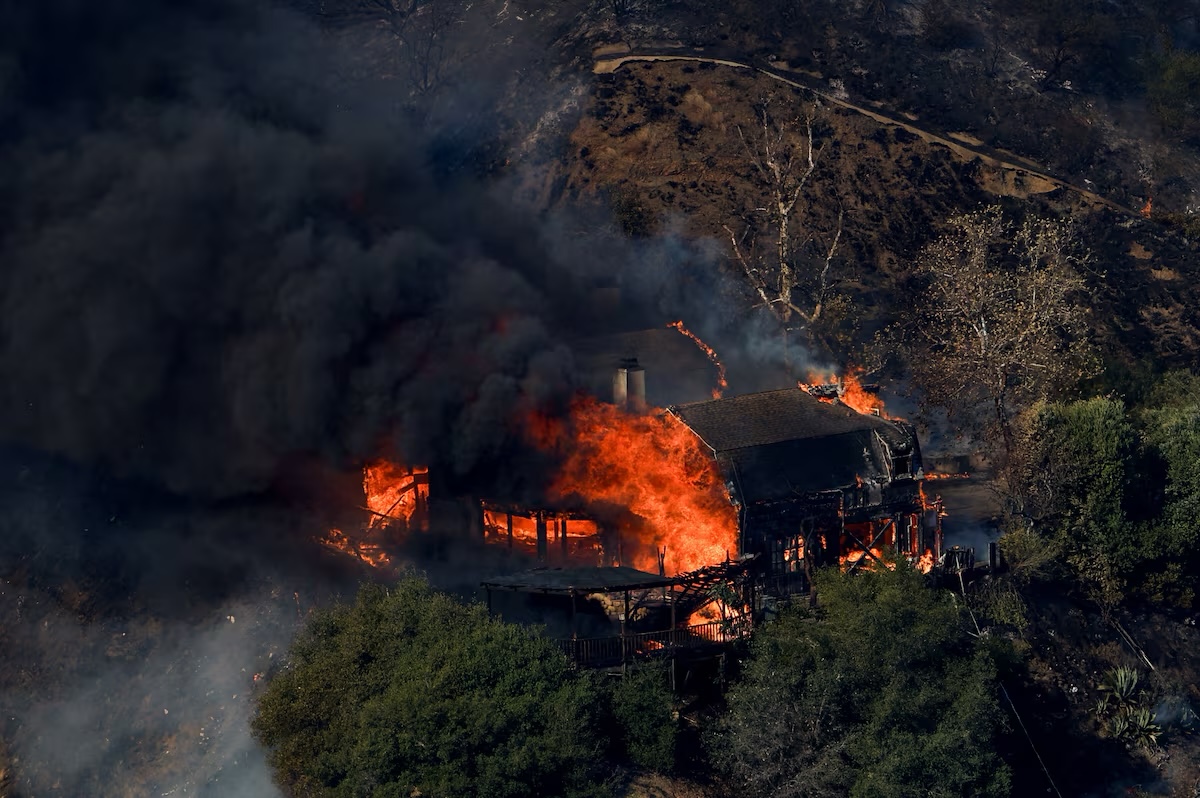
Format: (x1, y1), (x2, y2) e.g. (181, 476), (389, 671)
(331, 336), (942, 595)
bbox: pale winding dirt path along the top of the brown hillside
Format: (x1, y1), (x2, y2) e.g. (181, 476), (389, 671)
(592, 46), (1140, 216)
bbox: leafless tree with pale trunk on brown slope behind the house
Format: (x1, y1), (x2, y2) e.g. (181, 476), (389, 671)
(725, 98), (842, 348)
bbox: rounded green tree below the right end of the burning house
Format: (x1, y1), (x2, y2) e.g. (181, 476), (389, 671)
(708, 564), (1009, 798)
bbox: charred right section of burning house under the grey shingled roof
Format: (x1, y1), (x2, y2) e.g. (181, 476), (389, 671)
(670, 383), (942, 594)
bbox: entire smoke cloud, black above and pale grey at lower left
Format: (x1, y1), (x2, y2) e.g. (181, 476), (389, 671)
(0, 0), (758, 796)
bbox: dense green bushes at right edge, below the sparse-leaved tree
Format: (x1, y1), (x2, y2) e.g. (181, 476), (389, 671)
(1002, 373), (1200, 606)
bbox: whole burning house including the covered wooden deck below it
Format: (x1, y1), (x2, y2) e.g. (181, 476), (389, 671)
(326, 348), (942, 666)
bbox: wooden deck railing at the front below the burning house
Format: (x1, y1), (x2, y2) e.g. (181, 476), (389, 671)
(557, 617), (750, 667)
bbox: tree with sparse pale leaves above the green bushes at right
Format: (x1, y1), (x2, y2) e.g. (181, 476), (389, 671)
(902, 206), (1092, 456)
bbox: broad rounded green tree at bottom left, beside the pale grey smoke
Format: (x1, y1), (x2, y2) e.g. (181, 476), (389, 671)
(253, 578), (604, 798)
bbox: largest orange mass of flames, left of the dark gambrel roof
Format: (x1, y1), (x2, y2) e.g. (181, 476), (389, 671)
(529, 397), (738, 575)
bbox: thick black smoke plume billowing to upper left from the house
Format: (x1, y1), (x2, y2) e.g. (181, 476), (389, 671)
(0, 0), (600, 496)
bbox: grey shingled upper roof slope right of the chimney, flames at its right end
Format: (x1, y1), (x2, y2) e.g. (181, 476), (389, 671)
(667, 388), (916, 454)
